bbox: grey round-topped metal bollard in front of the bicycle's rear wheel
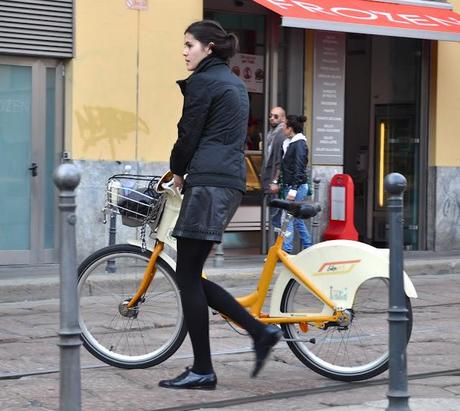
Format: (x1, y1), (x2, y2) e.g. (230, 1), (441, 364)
(384, 173), (410, 411)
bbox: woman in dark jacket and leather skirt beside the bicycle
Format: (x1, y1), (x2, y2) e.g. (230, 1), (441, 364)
(159, 20), (282, 389)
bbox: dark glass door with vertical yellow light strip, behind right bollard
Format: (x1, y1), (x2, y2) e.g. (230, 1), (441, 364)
(368, 36), (427, 250)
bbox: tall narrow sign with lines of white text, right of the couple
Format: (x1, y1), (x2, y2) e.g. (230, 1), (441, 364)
(312, 31), (345, 165)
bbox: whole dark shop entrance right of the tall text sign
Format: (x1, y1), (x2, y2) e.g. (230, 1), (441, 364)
(344, 34), (428, 250)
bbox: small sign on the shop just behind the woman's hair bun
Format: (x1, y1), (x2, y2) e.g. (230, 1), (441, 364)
(229, 53), (265, 93)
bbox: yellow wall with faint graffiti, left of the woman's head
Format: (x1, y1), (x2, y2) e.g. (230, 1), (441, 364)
(66, 0), (203, 161)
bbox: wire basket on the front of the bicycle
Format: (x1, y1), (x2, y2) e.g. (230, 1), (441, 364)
(105, 174), (165, 231)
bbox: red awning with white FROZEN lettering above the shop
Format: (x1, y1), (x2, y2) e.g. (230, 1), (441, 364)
(254, 0), (460, 41)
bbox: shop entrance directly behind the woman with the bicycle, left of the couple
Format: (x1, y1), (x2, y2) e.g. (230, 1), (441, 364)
(203, 0), (305, 254)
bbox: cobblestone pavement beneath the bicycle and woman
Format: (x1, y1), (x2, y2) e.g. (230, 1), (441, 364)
(0, 274), (460, 411)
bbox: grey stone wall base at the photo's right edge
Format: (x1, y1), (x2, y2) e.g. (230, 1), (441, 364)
(430, 167), (460, 251)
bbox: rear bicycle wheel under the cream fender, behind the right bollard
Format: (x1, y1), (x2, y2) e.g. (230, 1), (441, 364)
(281, 277), (412, 381)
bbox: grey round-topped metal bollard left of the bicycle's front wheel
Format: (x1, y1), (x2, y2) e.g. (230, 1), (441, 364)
(53, 163), (81, 411)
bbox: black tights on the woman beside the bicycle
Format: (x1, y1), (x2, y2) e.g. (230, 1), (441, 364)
(176, 237), (265, 374)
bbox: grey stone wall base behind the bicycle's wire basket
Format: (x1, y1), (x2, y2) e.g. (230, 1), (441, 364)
(74, 160), (168, 263)
